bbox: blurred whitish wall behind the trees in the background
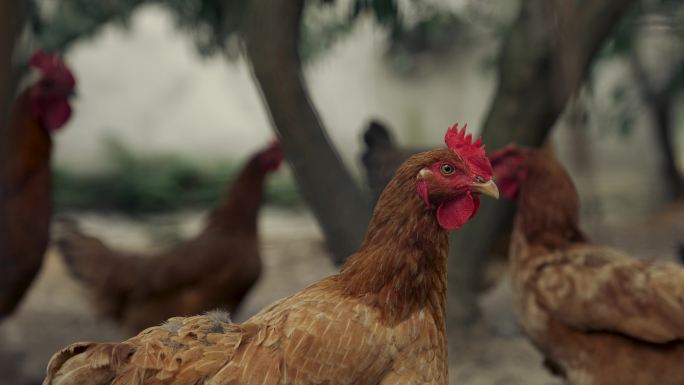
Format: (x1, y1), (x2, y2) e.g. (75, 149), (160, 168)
(50, 7), (493, 171)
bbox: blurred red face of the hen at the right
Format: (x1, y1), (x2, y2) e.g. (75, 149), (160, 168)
(489, 144), (529, 200)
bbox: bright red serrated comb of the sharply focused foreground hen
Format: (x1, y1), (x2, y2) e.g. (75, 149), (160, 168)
(444, 123), (492, 178)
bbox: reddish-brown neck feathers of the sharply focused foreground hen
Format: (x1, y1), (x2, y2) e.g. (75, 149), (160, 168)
(337, 153), (448, 324)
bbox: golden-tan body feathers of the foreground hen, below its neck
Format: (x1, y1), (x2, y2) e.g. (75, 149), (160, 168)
(45, 280), (445, 385)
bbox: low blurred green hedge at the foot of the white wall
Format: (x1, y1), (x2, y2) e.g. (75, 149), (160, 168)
(54, 142), (302, 212)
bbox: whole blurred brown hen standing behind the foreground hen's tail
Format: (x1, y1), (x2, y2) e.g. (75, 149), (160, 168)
(58, 143), (283, 333)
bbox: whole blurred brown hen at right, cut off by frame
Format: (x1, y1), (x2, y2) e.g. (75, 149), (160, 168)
(490, 145), (684, 385)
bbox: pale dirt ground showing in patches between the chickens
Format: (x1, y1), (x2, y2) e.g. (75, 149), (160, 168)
(0, 205), (684, 385)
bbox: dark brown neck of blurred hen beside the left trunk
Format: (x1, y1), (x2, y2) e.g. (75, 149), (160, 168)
(208, 156), (266, 232)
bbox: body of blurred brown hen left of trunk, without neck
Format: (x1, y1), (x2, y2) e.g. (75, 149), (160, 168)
(58, 220), (261, 333)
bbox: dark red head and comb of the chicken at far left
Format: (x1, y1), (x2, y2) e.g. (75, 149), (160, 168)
(30, 50), (76, 131)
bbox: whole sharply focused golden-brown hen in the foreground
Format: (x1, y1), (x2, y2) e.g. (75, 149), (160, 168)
(44, 127), (498, 385)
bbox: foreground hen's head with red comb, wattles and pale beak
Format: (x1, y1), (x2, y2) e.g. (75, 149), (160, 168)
(417, 124), (499, 231)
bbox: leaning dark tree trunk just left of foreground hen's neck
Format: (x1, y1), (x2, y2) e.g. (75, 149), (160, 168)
(243, 0), (370, 263)
